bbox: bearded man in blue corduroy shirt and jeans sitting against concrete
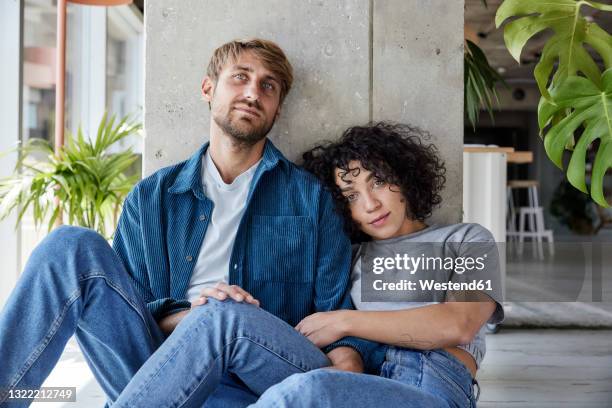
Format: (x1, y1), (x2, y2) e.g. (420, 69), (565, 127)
(0, 39), (371, 406)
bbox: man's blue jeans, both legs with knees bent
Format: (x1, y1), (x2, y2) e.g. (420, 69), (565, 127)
(0, 227), (329, 407)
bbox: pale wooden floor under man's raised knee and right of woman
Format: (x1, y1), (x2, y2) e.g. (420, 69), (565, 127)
(37, 328), (612, 408)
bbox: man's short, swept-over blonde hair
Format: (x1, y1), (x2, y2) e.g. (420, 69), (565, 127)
(206, 38), (293, 103)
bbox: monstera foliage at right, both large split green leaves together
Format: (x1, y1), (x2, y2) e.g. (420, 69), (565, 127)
(495, 0), (612, 207)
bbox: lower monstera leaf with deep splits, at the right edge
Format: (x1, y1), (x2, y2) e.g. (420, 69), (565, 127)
(538, 68), (612, 207)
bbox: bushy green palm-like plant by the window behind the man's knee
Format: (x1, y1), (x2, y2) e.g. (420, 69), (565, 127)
(0, 114), (142, 239)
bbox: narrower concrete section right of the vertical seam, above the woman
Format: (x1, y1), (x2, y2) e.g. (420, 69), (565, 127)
(372, 0), (464, 222)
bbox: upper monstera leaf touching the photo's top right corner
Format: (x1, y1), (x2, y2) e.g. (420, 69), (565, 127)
(495, 0), (612, 98)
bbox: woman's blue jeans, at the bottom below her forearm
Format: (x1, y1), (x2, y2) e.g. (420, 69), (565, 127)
(251, 347), (476, 408)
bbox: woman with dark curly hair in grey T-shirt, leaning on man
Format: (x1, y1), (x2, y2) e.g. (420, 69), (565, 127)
(249, 123), (503, 408)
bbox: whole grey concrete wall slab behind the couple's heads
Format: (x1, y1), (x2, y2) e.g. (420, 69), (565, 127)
(144, 0), (464, 222)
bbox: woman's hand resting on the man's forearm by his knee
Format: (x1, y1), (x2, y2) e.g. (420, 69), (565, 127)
(295, 310), (351, 348)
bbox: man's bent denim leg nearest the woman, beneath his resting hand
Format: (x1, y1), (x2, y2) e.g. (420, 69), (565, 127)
(113, 299), (329, 408)
